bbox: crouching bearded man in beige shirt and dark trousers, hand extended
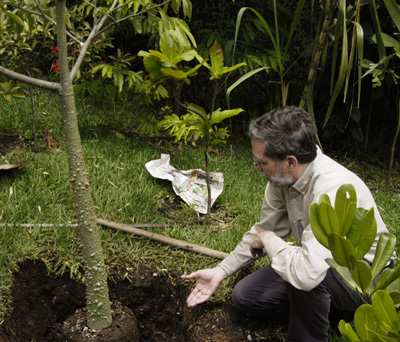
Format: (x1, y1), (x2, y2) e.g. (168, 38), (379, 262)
(186, 107), (387, 342)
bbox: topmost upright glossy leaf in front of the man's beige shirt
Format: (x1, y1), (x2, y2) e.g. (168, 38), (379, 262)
(335, 184), (357, 236)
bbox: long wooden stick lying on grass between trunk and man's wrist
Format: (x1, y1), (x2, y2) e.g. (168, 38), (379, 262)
(96, 218), (228, 259)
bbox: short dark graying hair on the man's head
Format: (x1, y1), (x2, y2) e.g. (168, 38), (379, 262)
(248, 106), (317, 164)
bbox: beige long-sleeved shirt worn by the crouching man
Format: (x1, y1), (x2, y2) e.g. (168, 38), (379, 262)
(219, 149), (388, 291)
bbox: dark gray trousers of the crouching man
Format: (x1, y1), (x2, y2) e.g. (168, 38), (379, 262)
(232, 265), (364, 342)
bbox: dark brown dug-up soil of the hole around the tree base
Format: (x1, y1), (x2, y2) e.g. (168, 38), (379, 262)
(0, 260), (285, 342)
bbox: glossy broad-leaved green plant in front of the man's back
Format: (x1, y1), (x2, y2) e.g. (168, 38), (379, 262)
(310, 184), (400, 342)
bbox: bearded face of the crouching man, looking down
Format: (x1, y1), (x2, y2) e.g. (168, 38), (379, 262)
(251, 140), (294, 187)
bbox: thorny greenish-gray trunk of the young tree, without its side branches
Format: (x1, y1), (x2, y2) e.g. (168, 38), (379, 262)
(57, 0), (112, 330)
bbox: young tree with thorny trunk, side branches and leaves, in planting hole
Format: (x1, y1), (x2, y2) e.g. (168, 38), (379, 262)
(0, 0), (190, 331)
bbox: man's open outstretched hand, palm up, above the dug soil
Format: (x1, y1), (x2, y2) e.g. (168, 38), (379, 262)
(185, 266), (228, 307)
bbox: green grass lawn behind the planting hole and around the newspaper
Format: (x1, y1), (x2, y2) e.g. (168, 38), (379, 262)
(0, 91), (400, 340)
